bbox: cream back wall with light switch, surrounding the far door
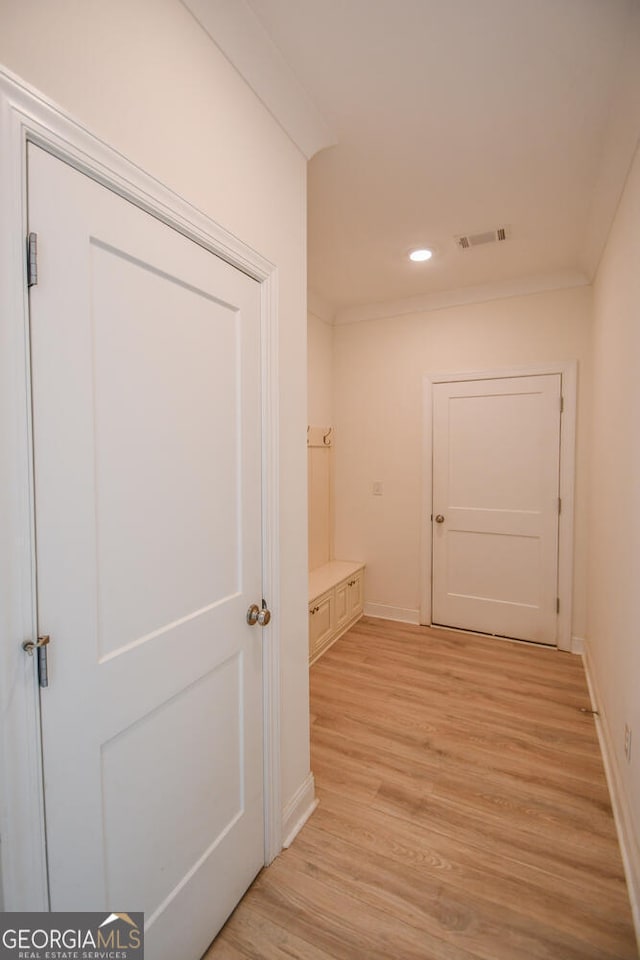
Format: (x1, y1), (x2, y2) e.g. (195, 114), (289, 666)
(333, 287), (591, 637)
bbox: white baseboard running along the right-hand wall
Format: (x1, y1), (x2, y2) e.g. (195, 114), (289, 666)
(583, 642), (640, 949)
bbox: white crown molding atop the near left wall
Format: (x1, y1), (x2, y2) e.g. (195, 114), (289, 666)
(182, 0), (336, 160)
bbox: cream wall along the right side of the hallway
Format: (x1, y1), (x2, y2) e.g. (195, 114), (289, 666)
(587, 142), (640, 933)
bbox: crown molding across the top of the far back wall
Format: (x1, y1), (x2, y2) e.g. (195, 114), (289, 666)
(333, 270), (590, 326)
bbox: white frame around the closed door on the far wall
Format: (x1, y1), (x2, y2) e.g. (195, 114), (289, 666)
(420, 360), (578, 650)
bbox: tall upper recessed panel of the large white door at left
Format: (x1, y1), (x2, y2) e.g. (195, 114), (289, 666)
(91, 242), (241, 656)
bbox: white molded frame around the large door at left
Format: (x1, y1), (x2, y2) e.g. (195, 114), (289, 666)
(0, 69), (282, 910)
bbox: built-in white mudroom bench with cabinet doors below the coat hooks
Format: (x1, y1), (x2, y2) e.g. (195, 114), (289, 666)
(309, 560), (364, 663)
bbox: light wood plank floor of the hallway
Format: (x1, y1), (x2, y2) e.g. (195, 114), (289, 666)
(207, 618), (637, 960)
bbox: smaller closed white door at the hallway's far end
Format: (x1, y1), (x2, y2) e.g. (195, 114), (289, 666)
(432, 374), (561, 644)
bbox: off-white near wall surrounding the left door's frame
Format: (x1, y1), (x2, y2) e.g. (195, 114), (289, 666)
(0, 0), (309, 840)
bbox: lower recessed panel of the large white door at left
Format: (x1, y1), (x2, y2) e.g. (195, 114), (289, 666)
(101, 656), (243, 906)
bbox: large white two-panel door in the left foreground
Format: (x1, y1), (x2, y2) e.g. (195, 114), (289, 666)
(28, 146), (264, 960)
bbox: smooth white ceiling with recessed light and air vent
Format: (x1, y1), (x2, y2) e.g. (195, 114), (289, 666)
(242, 0), (640, 319)
